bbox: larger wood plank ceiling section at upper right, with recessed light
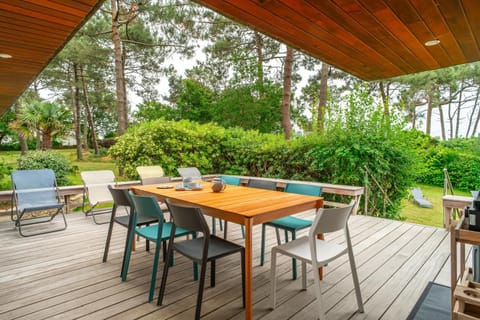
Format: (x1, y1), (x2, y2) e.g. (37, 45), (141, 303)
(195, 0), (480, 80)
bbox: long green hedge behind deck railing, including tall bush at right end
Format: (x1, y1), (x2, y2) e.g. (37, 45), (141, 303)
(109, 106), (415, 218)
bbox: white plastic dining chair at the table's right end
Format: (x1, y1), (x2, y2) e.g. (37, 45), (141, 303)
(270, 201), (363, 320)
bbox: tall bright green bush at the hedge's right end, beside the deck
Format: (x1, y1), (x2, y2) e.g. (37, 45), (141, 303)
(310, 88), (416, 218)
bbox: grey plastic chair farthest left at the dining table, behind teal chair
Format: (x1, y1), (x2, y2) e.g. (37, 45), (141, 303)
(102, 186), (159, 273)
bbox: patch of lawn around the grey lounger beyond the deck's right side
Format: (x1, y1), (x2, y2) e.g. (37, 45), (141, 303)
(401, 185), (470, 228)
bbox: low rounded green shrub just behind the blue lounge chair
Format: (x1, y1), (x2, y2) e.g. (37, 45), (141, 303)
(17, 151), (71, 186)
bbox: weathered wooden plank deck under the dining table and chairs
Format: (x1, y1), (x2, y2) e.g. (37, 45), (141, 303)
(0, 213), (450, 320)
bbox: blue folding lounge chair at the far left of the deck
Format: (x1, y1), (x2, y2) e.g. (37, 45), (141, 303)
(11, 169), (67, 237)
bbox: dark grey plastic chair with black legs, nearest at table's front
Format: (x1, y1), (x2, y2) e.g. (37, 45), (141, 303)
(157, 199), (245, 320)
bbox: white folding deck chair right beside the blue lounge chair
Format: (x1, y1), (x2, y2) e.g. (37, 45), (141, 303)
(80, 170), (116, 224)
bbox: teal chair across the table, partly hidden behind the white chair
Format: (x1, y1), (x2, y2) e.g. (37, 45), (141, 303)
(260, 183), (322, 280)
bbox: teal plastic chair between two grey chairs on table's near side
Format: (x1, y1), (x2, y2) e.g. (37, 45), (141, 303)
(122, 191), (198, 302)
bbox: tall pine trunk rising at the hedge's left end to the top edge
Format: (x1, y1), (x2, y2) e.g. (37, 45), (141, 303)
(111, 0), (128, 136)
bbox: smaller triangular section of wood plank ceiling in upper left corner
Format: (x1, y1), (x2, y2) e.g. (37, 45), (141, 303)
(0, 0), (103, 114)
